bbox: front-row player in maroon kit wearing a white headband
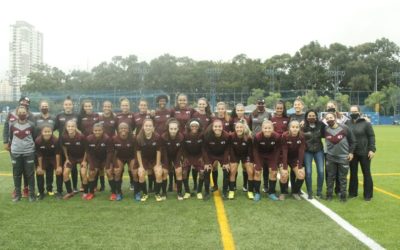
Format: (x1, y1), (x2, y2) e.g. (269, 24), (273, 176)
(182, 118), (205, 200)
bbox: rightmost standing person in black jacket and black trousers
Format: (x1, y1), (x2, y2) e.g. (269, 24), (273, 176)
(346, 106), (376, 201)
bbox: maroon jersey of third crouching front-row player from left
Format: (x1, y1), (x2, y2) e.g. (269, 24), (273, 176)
(86, 134), (114, 166)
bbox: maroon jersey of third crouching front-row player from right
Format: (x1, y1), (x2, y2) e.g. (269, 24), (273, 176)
(230, 133), (253, 164)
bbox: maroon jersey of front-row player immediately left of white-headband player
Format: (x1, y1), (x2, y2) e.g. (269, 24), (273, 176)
(161, 132), (183, 164)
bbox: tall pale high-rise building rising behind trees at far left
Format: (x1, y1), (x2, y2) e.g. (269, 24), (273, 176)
(9, 21), (43, 101)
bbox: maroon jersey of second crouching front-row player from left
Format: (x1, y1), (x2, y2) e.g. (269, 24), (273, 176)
(61, 132), (86, 159)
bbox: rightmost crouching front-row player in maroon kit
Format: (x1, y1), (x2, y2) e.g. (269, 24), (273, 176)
(280, 120), (306, 200)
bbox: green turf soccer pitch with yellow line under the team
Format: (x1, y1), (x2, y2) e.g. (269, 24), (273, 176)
(0, 126), (400, 249)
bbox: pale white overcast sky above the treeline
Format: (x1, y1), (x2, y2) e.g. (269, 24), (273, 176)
(0, 0), (400, 75)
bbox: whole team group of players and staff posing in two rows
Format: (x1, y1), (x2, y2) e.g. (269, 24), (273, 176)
(3, 94), (375, 201)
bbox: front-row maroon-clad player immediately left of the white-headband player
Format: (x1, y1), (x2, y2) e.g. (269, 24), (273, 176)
(161, 118), (185, 200)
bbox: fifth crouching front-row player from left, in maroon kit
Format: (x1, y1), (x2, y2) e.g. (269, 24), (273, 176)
(135, 119), (163, 202)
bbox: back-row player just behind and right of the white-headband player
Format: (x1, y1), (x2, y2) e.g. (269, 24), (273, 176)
(190, 97), (213, 193)
